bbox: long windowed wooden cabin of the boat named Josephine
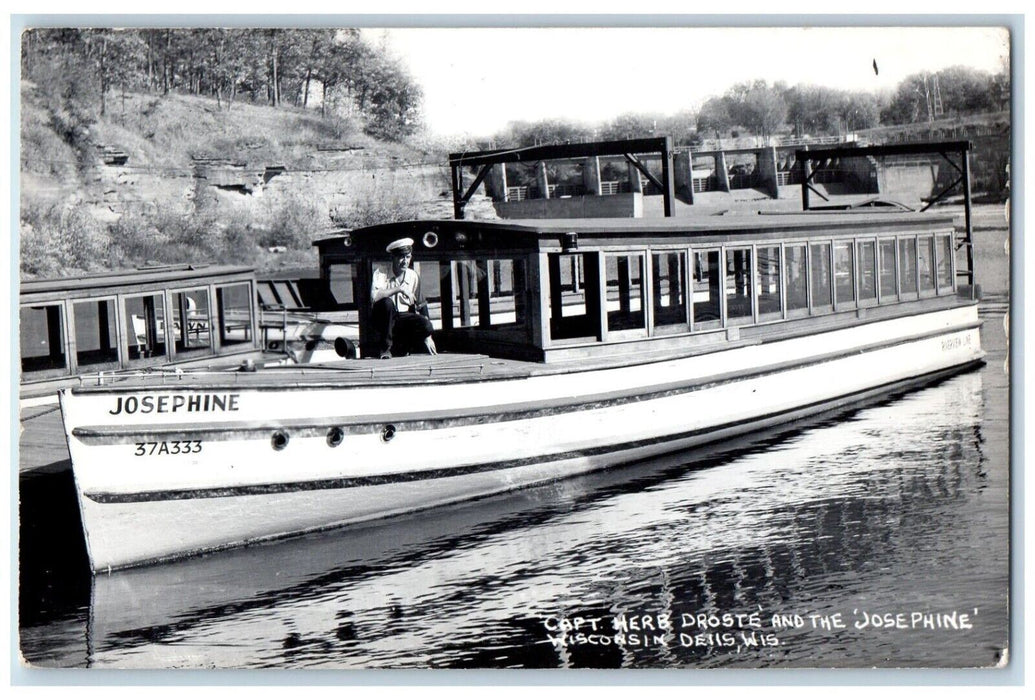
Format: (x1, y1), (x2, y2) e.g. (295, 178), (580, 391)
(314, 212), (971, 362)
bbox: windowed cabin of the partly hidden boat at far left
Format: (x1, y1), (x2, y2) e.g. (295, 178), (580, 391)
(19, 265), (261, 396)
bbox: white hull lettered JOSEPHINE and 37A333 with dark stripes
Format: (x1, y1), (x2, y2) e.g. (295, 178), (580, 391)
(61, 305), (982, 571)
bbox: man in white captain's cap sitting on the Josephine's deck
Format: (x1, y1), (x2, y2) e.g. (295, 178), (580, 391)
(371, 238), (438, 359)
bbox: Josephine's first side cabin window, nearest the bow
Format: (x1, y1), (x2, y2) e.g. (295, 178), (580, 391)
(546, 253), (600, 340)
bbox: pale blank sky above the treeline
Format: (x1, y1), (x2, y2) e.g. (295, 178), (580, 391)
(364, 27), (1009, 137)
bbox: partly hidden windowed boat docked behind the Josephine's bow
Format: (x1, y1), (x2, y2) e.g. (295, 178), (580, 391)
(19, 263), (364, 408)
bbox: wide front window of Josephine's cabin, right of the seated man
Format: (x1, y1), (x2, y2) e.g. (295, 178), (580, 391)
(451, 259), (525, 328)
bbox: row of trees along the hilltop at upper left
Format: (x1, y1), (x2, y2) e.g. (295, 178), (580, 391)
(22, 27), (423, 141)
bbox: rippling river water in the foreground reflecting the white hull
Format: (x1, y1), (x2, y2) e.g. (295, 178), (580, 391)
(21, 296), (1009, 669)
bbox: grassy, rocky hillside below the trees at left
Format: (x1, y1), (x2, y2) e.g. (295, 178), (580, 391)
(21, 82), (465, 276)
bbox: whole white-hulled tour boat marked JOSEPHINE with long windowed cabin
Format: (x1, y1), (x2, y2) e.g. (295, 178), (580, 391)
(60, 197), (983, 572)
